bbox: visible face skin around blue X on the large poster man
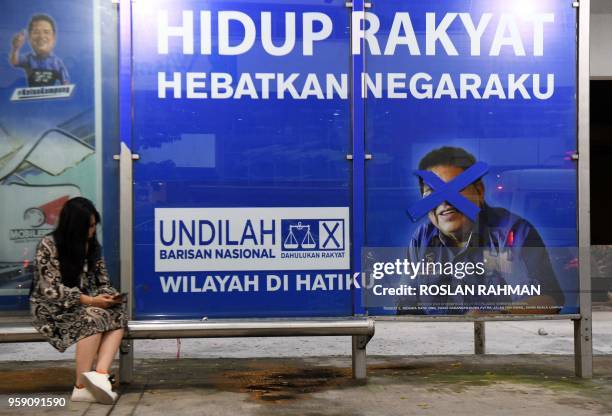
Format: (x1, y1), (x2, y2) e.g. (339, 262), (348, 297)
(423, 165), (484, 242)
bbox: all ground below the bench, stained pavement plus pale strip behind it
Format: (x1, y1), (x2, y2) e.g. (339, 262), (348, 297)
(0, 311), (612, 416)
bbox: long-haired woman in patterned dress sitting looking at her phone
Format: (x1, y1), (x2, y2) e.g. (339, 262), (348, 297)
(30, 197), (127, 404)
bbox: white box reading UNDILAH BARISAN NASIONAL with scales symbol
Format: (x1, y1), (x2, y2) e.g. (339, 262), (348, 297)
(155, 207), (350, 272)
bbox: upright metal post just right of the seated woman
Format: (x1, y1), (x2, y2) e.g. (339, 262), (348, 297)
(118, 0), (134, 383)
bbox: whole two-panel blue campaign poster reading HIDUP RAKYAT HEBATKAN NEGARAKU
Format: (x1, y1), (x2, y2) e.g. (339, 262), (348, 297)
(131, 0), (578, 318)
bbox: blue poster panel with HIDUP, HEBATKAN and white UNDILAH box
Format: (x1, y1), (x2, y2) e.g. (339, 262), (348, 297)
(131, 0), (354, 319)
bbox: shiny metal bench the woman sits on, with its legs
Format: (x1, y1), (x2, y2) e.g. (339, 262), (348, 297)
(0, 318), (374, 382)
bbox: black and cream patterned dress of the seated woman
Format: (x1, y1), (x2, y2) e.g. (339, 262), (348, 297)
(30, 236), (127, 352)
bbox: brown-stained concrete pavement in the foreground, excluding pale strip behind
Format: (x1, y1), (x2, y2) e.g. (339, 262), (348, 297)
(0, 355), (612, 416)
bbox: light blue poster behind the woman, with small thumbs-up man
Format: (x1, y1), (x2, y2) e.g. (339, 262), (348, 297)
(0, 0), (99, 310)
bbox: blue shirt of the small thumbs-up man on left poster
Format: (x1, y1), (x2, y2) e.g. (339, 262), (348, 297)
(16, 52), (70, 87)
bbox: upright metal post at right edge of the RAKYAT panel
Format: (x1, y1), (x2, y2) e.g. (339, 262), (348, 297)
(574, 0), (593, 378)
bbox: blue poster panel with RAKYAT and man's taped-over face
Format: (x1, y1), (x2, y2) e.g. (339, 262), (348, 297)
(364, 0), (578, 315)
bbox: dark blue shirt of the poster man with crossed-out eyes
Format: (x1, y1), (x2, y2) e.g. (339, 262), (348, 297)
(398, 204), (565, 315)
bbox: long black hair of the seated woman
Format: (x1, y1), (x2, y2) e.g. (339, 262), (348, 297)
(53, 197), (100, 287)
